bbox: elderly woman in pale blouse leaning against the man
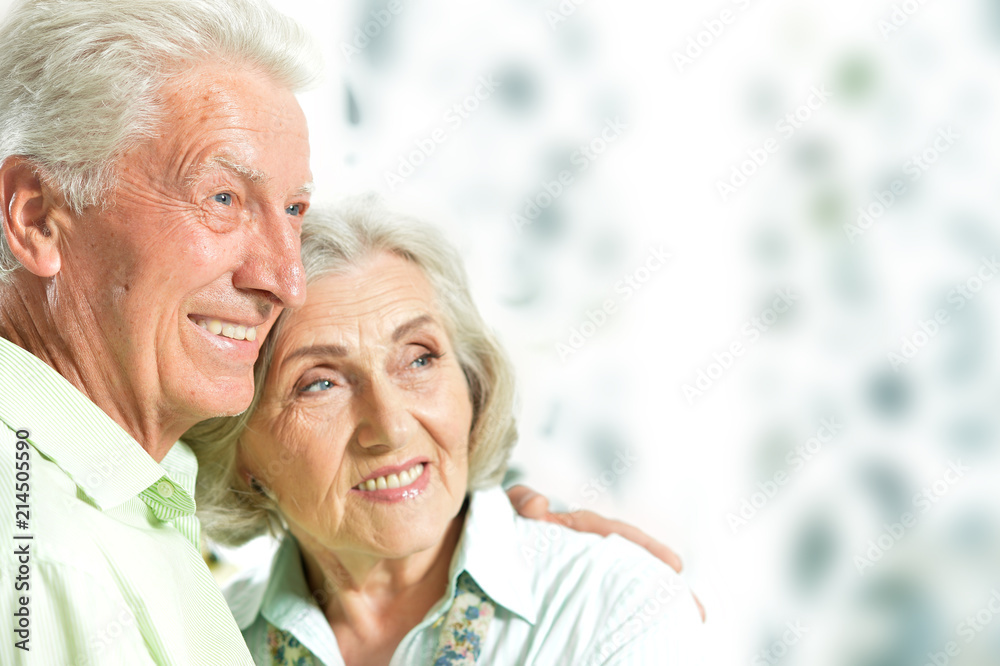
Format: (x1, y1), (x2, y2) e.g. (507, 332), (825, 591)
(186, 199), (700, 666)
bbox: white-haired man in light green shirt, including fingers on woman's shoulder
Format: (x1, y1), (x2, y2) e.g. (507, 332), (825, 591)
(0, 0), (688, 666)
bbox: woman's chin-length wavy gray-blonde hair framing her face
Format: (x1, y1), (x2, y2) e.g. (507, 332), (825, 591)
(184, 195), (517, 545)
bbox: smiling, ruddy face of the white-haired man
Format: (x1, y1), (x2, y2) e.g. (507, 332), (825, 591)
(56, 64), (311, 419)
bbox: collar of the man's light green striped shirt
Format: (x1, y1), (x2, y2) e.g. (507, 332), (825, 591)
(0, 338), (197, 521)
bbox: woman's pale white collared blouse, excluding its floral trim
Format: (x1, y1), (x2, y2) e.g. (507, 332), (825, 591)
(225, 488), (703, 666)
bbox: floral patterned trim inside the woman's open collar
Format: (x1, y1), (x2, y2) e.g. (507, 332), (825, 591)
(258, 571), (494, 666)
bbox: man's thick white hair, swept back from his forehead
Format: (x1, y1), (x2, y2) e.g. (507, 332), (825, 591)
(0, 0), (322, 285)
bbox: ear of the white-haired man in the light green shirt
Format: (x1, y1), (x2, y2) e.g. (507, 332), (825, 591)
(0, 155), (68, 278)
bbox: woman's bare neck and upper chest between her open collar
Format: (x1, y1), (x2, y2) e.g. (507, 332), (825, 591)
(299, 511), (465, 666)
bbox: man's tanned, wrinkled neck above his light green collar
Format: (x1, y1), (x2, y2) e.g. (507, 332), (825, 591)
(0, 282), (183, 462)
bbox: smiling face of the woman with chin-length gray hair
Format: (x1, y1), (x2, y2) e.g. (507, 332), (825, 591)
(240, 253), (472, 558)
